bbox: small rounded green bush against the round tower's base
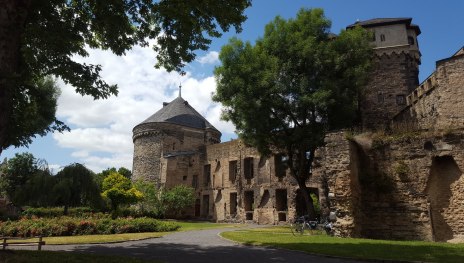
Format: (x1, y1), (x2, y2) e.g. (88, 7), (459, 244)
(163, 185), (195, 217)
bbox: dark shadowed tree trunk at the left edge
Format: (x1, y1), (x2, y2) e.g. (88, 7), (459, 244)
(0, 0), (31, 154)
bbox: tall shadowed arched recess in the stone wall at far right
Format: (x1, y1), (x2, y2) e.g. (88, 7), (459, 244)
(426, 155), (462, 241)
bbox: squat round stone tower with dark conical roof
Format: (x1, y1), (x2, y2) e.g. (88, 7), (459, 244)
(132, 94), (221, 184)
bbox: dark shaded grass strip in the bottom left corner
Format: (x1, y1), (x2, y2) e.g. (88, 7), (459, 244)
(0, 250), (160, 263)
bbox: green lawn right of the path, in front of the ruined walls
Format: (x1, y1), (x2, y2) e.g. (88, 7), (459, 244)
(222, 227), (464, 263)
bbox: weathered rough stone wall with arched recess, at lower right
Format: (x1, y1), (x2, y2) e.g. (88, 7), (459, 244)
(314, 130), (464, 241)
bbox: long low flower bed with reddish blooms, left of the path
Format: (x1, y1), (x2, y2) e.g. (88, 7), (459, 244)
(0, 216), (180, 237)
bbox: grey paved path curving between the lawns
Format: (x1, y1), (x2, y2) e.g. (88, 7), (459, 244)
(36, 228), (370, 263)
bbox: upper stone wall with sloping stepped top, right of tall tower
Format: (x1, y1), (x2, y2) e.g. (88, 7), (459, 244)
(394, 54), (464, 130)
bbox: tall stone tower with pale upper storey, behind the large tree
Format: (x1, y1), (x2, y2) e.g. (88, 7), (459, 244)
(347, 18), (421, 130)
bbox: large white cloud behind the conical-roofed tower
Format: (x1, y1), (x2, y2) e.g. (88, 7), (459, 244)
(53, 44), (234, 172)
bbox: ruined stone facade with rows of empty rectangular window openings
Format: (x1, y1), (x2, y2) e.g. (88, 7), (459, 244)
(201, 140), (297, 224)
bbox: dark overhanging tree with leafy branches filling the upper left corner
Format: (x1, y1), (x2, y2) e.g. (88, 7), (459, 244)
(0, 0), (251, 156)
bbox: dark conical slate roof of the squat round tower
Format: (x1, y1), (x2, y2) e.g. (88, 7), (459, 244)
(140, 96), (218, 131)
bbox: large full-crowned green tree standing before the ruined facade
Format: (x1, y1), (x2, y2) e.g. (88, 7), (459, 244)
(213, 9), (372, 218)
